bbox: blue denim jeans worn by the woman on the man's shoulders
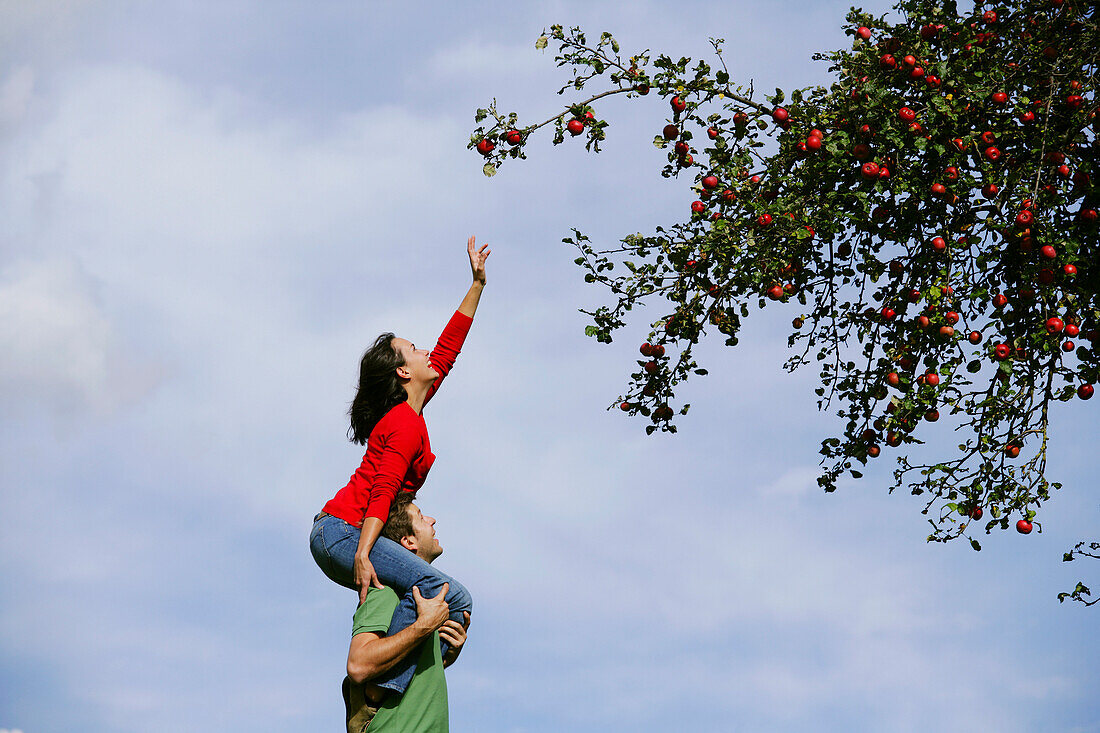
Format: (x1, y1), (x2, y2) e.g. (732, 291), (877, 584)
(309, 513), (473, 694)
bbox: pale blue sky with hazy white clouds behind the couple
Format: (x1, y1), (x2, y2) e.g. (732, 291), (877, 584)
(0, 0), (1100, 733)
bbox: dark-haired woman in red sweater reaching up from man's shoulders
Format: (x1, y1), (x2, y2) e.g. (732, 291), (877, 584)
(309, 237), (490, 693)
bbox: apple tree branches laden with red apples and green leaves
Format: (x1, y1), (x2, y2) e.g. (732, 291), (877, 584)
(470, 0), (1100, 603)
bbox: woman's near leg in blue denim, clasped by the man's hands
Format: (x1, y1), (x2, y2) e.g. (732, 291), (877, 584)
(371, 530), (473, 693)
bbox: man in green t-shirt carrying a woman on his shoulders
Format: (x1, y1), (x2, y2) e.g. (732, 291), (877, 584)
(343, 492), (470, 733)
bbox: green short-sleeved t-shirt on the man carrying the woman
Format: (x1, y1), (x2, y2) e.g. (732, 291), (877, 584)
(351, 588), (449, 733)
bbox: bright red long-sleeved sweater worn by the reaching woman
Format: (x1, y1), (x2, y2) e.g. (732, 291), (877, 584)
(325, 311), (473, 527)
